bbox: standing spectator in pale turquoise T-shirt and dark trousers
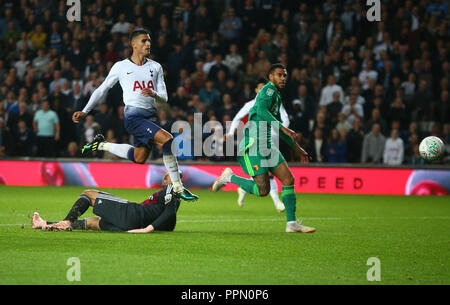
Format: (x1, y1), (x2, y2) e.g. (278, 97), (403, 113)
(33, 100), (60, 158)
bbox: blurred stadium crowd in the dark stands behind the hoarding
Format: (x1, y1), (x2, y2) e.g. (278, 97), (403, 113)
(0, 0), (450, 165)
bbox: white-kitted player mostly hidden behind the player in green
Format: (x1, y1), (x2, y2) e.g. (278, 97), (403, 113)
(225, 79), (289, 212)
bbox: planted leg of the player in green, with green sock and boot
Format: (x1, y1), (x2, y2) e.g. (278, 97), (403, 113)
(272, 161), (316, 233)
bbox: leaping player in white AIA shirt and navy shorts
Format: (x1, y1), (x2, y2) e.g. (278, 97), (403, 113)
(72, 29), (198, 201)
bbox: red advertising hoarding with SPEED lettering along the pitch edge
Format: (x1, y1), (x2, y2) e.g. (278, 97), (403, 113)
(0, 161), (450, 195)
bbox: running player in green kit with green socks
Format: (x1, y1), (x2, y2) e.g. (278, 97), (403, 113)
(212, 64), (315, 233)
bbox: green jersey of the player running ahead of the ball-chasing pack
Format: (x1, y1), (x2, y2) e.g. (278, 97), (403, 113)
(248, 82), (294, 147)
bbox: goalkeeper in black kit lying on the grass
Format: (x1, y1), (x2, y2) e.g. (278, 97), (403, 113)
(32, 172), (180, 233)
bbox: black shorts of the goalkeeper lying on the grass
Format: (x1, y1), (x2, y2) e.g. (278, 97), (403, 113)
(93, 192), (144, 232)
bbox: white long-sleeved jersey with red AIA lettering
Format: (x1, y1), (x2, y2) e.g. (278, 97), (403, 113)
(83, 58), (167, 113)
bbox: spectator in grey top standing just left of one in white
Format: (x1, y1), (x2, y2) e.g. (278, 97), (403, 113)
(361, 123), (386, 163)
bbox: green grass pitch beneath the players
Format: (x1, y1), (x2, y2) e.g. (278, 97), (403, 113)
(0, 186), (450, 284)
